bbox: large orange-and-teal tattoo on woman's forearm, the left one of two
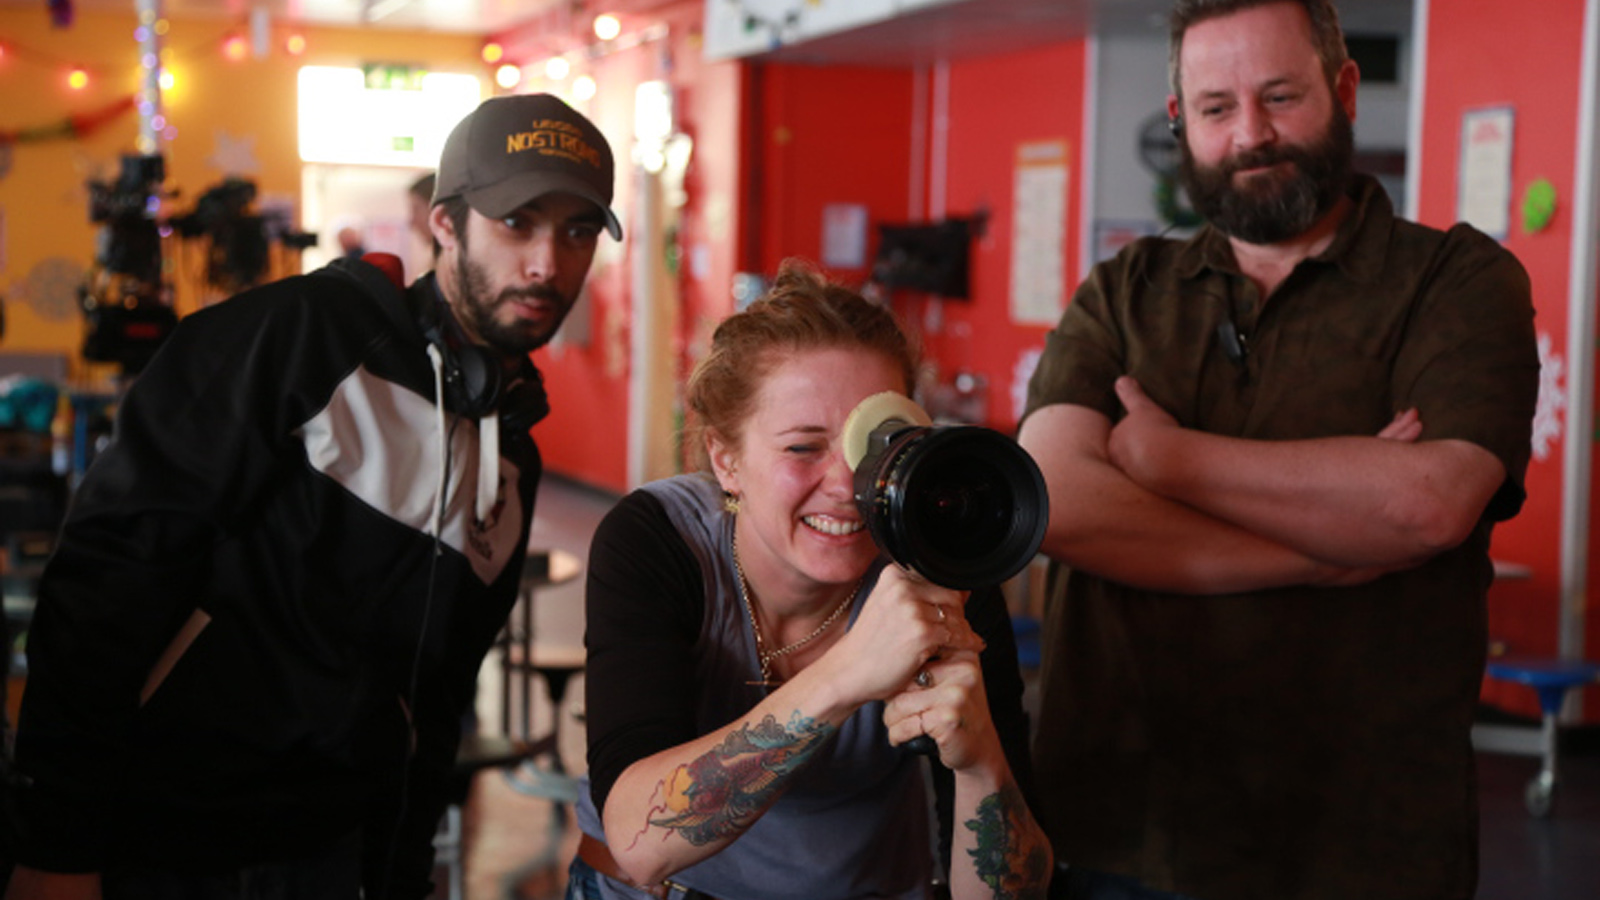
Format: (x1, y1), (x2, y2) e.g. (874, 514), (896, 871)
(646, 713), (837, 847)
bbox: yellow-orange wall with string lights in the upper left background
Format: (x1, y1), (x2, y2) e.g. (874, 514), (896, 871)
(0, 3), (491, 380)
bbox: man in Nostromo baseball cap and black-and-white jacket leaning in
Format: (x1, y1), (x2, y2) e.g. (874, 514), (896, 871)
(3, 94), (622, 900)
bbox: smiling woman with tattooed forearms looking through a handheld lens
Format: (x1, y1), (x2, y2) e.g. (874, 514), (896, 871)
(568, 256), (1051, 900)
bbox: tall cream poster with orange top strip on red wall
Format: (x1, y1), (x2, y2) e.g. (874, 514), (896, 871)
(1011, 141), (1067, 325)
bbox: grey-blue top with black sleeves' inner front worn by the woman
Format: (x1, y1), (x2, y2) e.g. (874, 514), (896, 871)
(578, 474), (934, 900)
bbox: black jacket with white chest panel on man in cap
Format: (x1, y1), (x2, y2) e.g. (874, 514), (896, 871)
(13, 256), (541, 897)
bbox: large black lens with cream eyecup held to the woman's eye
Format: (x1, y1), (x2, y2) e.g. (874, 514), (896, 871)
(843, 394), (1050, 591)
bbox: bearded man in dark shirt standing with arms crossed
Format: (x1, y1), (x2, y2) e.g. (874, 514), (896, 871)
(1019, 0), (1539, 900)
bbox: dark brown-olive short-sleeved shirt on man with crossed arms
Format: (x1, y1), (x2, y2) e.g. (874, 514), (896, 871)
(1027, 176), (1539, 900)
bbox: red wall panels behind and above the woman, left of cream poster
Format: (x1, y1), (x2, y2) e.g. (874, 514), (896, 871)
(750, 42), (1085, 431)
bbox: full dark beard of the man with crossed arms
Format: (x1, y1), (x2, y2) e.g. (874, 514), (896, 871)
(1178, 102), (1355, 243)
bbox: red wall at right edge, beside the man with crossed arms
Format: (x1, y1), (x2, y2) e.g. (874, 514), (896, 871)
(1419, 0), (1600, 714)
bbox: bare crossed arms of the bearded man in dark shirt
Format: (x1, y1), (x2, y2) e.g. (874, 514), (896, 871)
(1018, 376), (1506, 594)
